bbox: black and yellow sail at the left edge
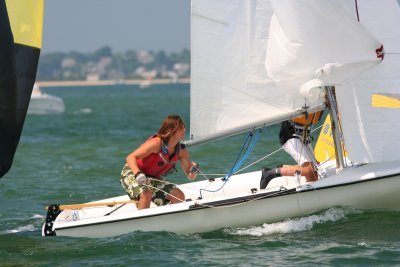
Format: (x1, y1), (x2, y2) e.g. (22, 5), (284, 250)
(0, 0), (44, 180)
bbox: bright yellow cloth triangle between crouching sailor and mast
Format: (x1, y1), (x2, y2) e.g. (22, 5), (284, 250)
(314, 114), (347, 163)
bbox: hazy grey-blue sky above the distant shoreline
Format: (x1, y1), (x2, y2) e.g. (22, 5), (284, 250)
(42, 0), (190, 54)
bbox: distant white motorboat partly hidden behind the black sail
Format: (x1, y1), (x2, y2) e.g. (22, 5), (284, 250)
(28, 84), (65, 115)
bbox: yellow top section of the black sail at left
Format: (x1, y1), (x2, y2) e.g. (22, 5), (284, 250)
(6, 0), (44, 48)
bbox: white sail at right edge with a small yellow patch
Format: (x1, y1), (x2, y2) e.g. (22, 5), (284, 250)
(336, 0), (400, 163)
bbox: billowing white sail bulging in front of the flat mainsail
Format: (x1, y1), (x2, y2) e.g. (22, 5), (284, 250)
(266, 0), (381, 100)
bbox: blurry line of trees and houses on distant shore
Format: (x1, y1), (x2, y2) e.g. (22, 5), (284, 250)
(36, 46), (190, 81)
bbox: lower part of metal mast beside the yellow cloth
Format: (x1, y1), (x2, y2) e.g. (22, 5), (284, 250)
(325, 86), (344, 171)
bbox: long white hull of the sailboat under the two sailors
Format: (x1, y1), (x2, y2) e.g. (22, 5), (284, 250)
(43, 162), (400, 237)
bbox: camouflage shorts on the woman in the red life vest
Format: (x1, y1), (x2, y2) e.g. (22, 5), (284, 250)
(120, 164), (176, 206)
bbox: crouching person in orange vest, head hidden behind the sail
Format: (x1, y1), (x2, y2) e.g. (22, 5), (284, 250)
(260, 111), (323, 189)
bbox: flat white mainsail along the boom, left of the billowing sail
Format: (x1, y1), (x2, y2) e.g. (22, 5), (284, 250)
(189, 0), (324, 147)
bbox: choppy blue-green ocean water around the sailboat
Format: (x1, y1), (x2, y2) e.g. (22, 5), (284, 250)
(0, 84), (400, 266)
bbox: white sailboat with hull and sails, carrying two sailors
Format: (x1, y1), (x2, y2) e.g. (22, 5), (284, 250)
(42, 0), (400, 237)
